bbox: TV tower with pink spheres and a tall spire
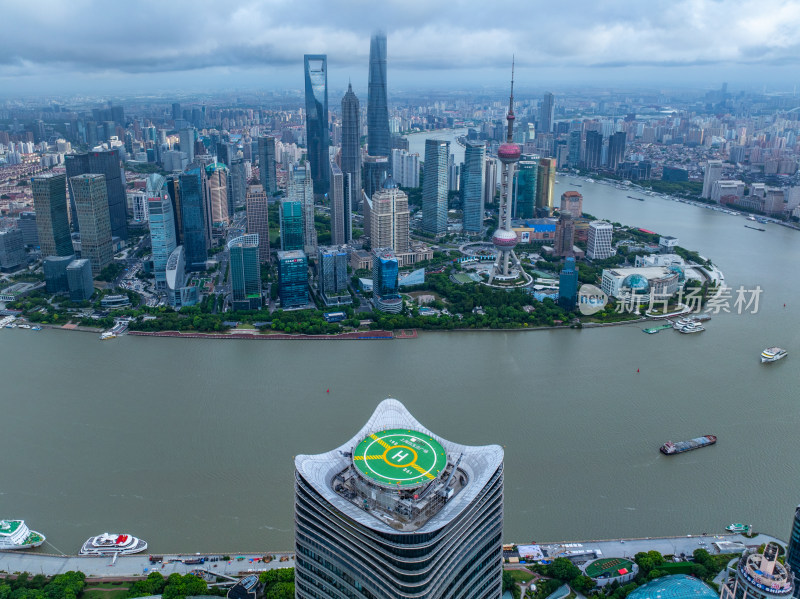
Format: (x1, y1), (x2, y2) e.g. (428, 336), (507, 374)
(489, 61), (520, 284)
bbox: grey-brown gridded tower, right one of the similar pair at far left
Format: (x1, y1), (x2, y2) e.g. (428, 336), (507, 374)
(70, 175), (114, 277)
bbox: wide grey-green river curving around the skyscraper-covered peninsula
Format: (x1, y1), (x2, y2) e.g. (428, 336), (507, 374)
(0, 177), (800, 553)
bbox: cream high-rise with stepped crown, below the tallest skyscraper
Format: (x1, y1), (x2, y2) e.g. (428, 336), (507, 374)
(369, 177), (411, 253)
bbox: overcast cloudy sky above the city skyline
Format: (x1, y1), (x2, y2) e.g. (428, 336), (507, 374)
(0, 0), (800, 96)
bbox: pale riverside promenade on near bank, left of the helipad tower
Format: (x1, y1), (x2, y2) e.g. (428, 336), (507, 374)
(0, 551), (294, 578)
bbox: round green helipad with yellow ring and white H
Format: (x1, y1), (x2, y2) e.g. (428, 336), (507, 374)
(353, 429), (447, 488)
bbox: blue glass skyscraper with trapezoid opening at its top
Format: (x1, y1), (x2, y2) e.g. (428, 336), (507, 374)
(304, 54), (330, 196)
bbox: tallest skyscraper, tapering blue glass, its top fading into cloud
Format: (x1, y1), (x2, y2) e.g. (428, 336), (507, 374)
(367, 33), (392, 157)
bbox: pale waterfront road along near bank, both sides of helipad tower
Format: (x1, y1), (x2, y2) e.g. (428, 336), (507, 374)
(0, 534), (785, 578)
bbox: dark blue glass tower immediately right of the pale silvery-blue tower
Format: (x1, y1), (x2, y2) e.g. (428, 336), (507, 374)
(180, 168), (211, 270)
